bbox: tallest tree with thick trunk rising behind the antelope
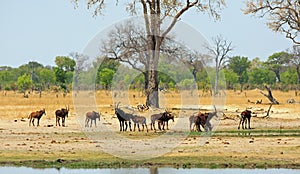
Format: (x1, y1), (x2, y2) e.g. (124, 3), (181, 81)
(74, 0), (225, 107)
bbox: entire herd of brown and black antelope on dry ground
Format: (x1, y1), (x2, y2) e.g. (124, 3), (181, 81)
(28, 103), (251, 132)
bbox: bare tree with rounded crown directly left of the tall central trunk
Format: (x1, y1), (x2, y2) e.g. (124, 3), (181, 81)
(101, 21), (150, 89)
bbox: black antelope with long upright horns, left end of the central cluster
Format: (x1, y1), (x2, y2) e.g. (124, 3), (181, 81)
(115, 102), (133, 131)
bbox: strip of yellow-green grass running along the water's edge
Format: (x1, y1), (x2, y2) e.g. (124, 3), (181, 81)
(0, 154), (300, 169)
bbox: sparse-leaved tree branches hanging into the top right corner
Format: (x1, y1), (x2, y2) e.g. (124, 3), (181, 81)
(244, 0), (300, 44)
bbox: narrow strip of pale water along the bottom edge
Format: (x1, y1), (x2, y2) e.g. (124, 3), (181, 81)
(0, 167), (300, 174)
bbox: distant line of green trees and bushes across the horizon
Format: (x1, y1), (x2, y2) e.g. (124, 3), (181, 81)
(0, 52), (300, 92)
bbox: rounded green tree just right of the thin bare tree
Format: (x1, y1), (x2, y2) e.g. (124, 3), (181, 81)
(228, 56), (250, 91)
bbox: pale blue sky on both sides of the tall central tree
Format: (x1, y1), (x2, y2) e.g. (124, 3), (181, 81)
(0, 0), (292, 67)
